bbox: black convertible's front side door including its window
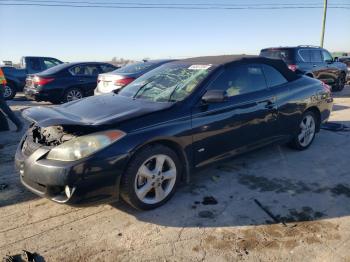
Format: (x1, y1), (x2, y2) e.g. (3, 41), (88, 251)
(192, 64), (277, 166)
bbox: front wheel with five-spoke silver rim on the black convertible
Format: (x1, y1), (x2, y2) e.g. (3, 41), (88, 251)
(120, 145), (182, 210)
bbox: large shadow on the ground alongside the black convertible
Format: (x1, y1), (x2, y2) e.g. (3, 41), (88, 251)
(113, 131), (350, 227)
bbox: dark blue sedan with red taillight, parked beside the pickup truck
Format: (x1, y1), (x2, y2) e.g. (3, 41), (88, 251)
(24, 62), (116, 104)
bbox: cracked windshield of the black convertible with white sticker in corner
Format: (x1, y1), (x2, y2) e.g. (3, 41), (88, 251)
(119, 63), (213, 102)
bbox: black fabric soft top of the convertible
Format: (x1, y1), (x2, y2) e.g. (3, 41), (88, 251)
(178, 55), (299, 81)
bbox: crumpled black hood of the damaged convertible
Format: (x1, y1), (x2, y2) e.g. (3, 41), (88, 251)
(22, 94), (173, 127)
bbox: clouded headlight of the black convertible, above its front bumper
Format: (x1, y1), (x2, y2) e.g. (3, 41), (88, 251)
(46, 130), (125, 161)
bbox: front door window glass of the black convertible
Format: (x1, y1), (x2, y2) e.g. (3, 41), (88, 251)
(209, 65), (267, 97)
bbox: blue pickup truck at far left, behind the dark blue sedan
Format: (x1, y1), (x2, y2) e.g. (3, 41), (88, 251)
(1, 56), (63, 100)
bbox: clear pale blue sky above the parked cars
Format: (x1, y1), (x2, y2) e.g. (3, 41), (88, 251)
(0, 0), (350, 62)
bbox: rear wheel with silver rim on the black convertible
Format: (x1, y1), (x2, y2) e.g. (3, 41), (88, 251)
(289, 111), (319, 150)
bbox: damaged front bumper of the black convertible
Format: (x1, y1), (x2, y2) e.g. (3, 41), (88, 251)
(15, 136), (128, 205)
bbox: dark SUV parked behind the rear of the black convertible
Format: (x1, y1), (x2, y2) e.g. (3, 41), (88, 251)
(260, 46), (347, 91)
